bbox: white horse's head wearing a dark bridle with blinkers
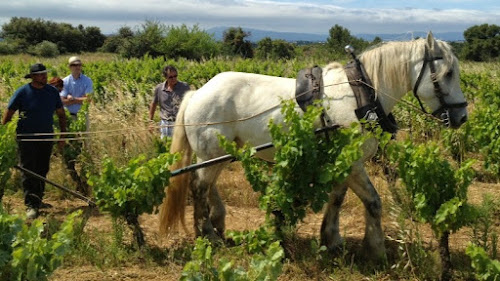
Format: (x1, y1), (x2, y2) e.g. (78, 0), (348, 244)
(412, 32), (467, 128)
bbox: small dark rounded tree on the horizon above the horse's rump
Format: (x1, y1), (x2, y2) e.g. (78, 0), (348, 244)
(222, 27), (253, 58)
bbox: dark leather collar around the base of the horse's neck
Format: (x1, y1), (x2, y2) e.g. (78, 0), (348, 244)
(344, 58), (398, 134)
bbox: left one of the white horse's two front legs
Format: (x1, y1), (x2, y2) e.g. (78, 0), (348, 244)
(321, 183), (347, 251)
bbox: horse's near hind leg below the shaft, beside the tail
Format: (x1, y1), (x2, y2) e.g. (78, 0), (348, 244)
(191, 165), (221, 242)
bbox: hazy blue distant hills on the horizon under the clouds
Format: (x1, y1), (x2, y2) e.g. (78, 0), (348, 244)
(206, 26), (464, 42)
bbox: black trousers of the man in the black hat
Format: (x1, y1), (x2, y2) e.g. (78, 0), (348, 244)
(18, 141), (54, 209)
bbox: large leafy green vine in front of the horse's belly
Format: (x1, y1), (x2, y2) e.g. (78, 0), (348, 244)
(220, 101), (367, 232)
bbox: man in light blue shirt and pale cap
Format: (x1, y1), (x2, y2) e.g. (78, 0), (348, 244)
(60, 57), (93, 119)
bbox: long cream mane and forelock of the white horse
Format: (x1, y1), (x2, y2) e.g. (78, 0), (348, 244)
(359, 38), (458, 93)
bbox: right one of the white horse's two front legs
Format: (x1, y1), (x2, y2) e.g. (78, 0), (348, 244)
(347, 165), (386, 259)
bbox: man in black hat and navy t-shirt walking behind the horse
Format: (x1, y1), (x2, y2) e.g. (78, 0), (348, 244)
(2, 63), (66, 219)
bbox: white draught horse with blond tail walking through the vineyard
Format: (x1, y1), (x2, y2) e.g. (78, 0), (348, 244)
(160, 33), (467, 258)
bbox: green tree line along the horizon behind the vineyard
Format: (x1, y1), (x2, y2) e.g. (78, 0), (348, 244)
(0, 17), (500, 61)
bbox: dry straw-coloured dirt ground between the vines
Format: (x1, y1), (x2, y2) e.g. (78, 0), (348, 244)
(3, 162), (500, 281)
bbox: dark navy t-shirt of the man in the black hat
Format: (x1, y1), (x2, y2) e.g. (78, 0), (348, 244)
(7, 84), (63, 137)
